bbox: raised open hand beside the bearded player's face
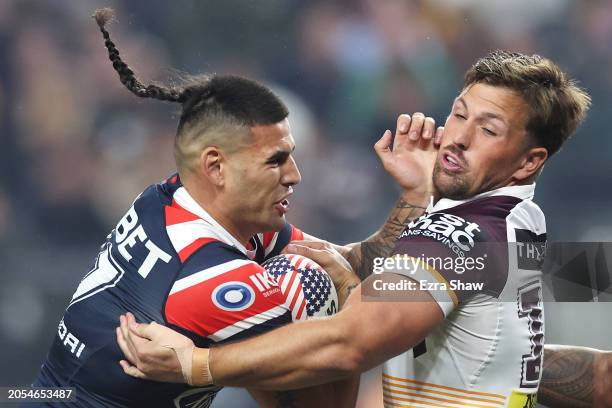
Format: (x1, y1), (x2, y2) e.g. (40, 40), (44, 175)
(374, 112), (444, 197)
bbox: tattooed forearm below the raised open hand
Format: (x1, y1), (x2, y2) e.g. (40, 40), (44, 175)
(347, 198), (425, 280)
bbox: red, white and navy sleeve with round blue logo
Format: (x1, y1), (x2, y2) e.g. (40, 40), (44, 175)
(165, 242), (291, 346)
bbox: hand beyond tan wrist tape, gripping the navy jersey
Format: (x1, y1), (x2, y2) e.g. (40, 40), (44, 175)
(116, 312), (195, 383)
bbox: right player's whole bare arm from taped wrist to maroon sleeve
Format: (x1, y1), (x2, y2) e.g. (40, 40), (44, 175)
(208, 282), (444, 390)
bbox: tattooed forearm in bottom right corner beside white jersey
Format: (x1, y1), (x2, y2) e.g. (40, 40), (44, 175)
(538, 347), (595, 408)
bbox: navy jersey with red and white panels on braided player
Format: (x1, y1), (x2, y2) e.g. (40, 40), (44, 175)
(34, 176), (303, 408)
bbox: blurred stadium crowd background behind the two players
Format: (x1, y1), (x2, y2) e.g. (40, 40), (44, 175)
(0, 0), (612, 407)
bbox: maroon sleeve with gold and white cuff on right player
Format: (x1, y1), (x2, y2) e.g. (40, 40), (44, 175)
(387, 212), (508, 316)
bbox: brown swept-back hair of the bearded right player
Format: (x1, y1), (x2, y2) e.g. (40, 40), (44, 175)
(464, 50), (591, 156)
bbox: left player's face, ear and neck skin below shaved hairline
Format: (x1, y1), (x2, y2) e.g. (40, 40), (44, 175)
(181, 119), (301, 245)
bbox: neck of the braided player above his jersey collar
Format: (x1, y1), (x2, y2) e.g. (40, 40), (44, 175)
(181, 176), (255, 247)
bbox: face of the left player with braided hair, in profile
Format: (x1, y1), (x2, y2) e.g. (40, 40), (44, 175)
(227, 119), (301, 232)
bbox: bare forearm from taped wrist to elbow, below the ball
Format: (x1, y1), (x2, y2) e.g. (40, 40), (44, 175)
(209, 310), (359, 390)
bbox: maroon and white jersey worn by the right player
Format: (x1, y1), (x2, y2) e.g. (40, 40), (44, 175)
(383, 185), (546, 408)
